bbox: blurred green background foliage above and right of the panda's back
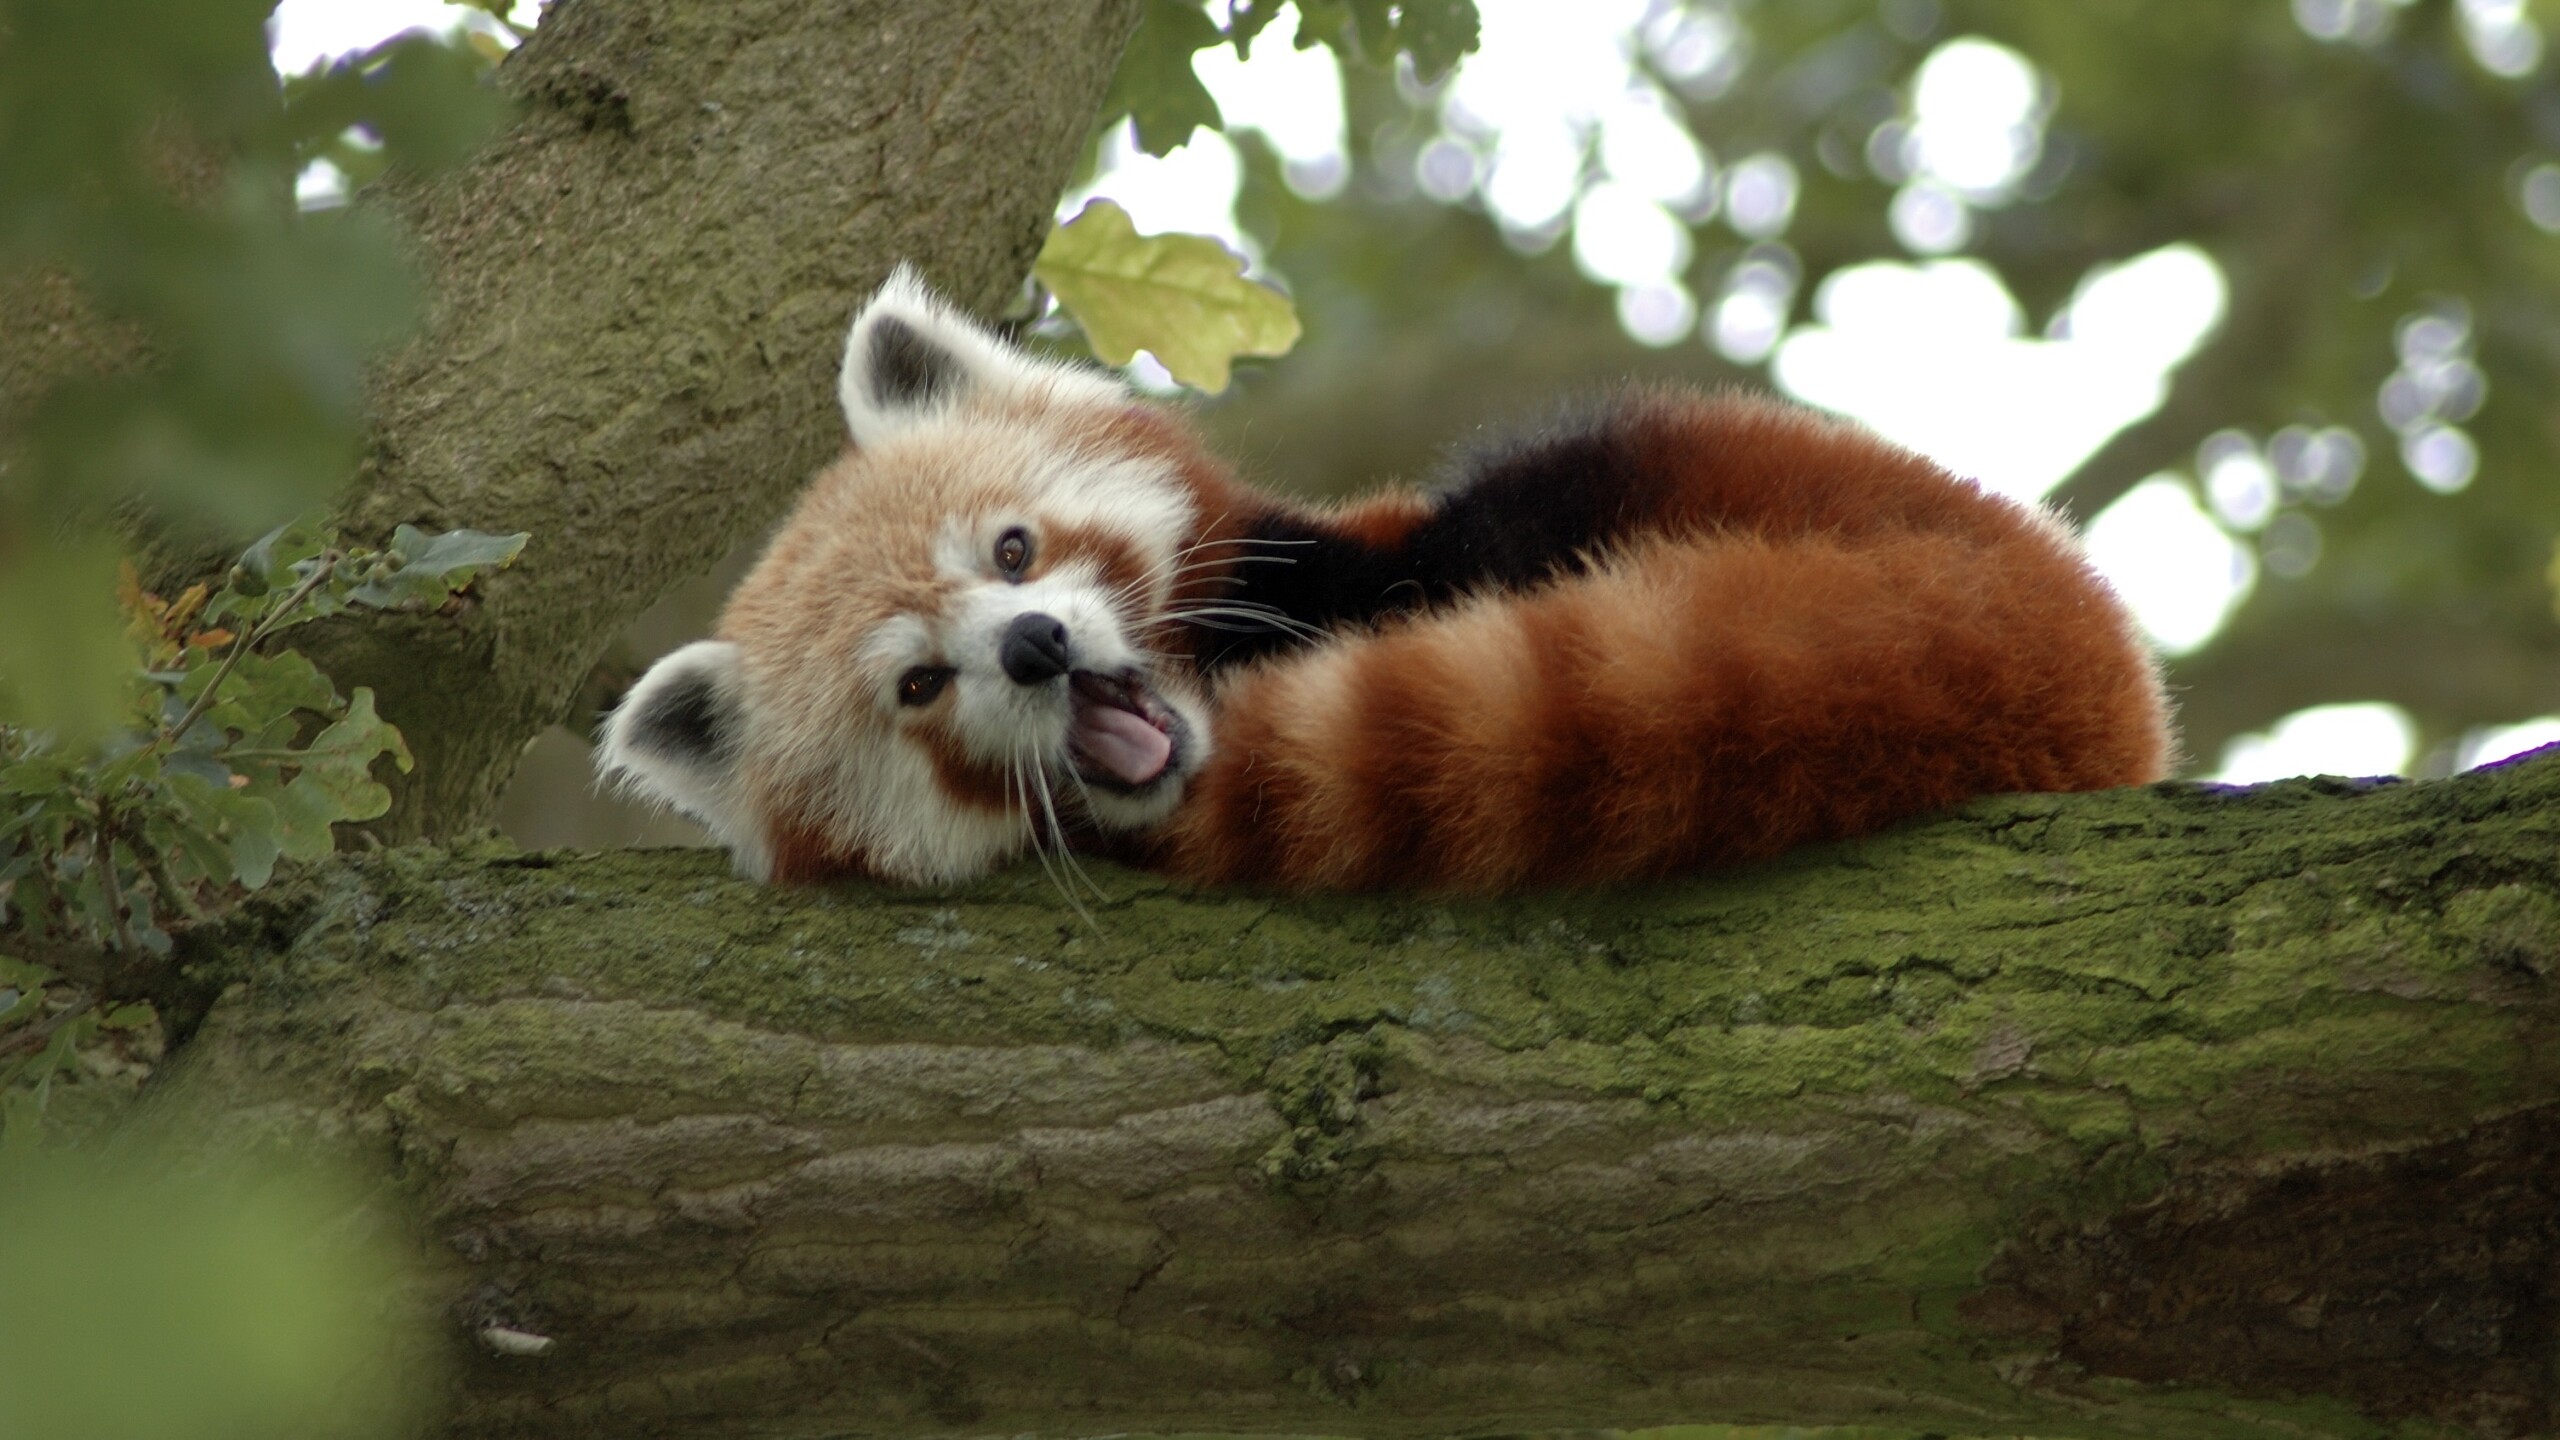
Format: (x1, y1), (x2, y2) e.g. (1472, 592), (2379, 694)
(1157, 0), (2560, 769)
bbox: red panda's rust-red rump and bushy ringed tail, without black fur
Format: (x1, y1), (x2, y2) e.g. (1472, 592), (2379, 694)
(1144, 395), (2171, 892)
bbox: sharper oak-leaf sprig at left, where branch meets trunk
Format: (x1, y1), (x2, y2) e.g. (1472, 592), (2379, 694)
(0, 523), (525, 1150)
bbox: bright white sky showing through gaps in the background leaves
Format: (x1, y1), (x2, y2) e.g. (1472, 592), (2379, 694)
(274, 0), (2560, 781)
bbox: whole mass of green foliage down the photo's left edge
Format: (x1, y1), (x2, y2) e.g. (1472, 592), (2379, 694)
(0, 14), (504, 1440)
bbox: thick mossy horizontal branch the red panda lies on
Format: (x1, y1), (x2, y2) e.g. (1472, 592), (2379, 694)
(172, 743), (2560, 1440)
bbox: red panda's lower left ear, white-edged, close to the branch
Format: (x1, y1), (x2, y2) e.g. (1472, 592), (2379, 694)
(596, 641), (765, 874)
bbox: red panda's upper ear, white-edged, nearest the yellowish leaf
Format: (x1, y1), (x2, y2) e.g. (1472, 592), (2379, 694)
(837, 264), (1126, 446)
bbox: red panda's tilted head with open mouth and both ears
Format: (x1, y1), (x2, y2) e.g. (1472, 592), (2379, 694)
(599, 266), (1221, 884)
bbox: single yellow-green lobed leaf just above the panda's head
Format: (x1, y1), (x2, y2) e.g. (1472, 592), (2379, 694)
(1032, 200), (1298, 392)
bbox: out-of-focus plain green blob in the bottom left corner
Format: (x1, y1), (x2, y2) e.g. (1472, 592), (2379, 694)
(0, 1133), (435, 1440)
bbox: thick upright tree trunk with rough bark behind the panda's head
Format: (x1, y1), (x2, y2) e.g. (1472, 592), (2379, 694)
(307, 0), (1137, 835)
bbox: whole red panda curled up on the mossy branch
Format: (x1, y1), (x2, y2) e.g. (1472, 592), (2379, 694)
(599, 269), (2171, 894)
